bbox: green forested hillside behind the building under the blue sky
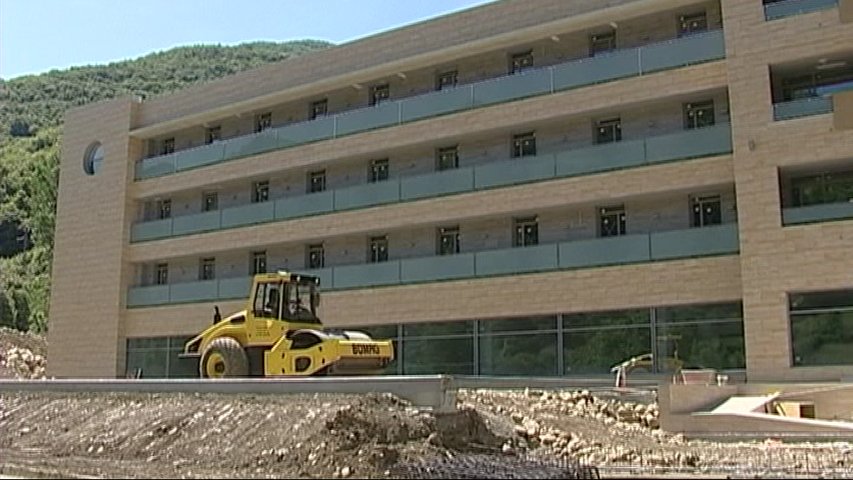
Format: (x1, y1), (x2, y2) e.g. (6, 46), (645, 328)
(0, 40), (331, 331)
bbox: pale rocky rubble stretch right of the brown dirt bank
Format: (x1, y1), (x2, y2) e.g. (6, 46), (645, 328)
(460, 390), (853, 478)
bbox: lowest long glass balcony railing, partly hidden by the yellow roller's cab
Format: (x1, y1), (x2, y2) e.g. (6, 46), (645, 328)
(127, 223), (739, 307)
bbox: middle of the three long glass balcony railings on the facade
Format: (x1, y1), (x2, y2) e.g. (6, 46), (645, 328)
(130, 124), (732, 242)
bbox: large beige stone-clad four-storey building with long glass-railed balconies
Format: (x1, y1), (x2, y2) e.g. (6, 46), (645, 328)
(49, 0), (853, 381)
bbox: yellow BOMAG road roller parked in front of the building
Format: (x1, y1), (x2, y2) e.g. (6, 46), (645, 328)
(181, 271), (394, 378)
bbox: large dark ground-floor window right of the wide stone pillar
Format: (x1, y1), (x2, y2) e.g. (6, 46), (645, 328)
(788, 290), (853, 367)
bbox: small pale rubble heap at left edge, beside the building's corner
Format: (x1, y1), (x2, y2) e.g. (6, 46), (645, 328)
(0, 327), (47, 379)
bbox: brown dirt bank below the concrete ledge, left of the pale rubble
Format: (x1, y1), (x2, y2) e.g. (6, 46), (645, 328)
(0, 394), (511, 478)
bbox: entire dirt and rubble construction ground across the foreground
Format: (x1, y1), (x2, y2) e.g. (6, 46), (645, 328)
(0, 331), (853, 478)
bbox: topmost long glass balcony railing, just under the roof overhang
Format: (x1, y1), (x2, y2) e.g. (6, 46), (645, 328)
(136, 30), (725, 180)
